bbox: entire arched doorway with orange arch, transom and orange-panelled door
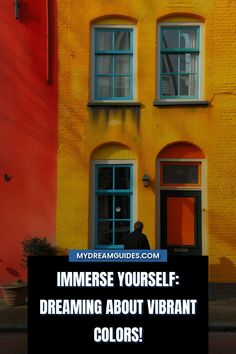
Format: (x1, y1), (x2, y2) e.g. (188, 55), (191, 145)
(157, 142), (207, 255)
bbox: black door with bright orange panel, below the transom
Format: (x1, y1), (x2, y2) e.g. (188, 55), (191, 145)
(161, 190), (201, 255)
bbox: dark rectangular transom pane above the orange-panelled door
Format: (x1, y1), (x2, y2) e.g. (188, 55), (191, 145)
(163, 164), (199, 184)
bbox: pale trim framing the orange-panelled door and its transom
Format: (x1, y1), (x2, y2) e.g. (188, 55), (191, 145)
(156, 158), (208, 256)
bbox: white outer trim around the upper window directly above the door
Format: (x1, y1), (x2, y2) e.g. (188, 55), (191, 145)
(156, 22), (205, 102)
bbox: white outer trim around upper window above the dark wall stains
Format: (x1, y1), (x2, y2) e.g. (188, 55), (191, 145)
(90, 24), (137, 104)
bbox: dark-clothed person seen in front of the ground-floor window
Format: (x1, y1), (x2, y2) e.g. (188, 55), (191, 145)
(124, 221), (150, 250)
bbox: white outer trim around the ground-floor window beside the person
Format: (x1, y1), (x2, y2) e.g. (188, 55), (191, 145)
(89, 160), (138, 249)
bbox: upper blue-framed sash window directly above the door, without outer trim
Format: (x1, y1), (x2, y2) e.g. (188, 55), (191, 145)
(160, 25), (200, 99)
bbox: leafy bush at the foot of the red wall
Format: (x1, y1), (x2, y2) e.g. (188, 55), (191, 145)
(22, 235), (57, 267)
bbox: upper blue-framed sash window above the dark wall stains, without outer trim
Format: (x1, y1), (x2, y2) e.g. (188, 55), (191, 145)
(94, 28), (134, 100)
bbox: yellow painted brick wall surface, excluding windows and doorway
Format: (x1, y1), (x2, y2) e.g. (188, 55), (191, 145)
(57, 0), (236, 282)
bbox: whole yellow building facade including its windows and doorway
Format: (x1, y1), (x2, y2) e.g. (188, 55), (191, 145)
(56, 0), (236, 282)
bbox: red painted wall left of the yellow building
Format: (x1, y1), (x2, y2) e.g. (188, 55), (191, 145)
(0, 0), (57, 284)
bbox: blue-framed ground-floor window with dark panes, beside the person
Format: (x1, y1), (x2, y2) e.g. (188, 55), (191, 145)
(95, 164), (133, 249)
